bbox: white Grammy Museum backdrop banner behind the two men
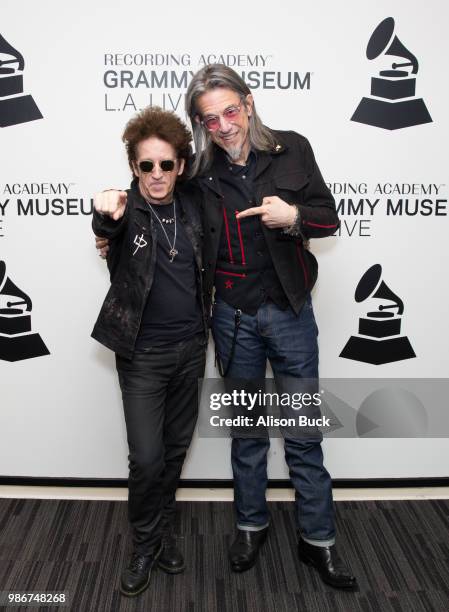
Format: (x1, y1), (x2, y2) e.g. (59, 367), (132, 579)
(0, 0), (449, 479)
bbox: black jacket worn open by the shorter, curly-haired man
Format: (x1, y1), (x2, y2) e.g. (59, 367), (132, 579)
(92, 180), (207, 359)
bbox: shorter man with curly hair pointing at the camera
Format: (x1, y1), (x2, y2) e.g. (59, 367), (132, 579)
(92, 107), (206, 596)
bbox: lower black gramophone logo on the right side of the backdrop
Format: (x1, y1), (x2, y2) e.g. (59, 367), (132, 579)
(340, 264), (416, 365)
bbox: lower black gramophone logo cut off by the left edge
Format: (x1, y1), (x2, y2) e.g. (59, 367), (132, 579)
(0, 261), (50, 361)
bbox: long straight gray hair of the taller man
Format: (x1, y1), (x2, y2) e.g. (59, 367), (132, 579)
(186, 64), (276, 176)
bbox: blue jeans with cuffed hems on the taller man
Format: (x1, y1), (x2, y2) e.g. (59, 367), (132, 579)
(212, 295), (335, 546)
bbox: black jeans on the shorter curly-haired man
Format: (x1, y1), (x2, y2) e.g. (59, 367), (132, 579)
(116, 335), (206, 554)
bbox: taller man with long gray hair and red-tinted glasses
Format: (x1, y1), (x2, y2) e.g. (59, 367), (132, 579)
(186, 64), (356, 589)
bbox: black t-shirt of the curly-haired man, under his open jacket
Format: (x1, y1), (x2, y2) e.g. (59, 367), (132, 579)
(136, 198), (202, 350)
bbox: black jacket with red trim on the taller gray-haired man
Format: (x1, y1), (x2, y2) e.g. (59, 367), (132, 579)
(198, 130), (340, 314)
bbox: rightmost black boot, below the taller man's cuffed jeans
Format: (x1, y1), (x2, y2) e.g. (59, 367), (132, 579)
(298, 536), (357, 590)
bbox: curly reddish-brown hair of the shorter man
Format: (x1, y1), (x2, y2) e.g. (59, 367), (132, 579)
(122, 106), (192, 176)
